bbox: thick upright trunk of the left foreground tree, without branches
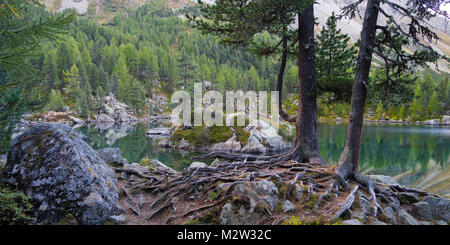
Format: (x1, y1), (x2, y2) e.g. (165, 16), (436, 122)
(292, 5), (323, 163)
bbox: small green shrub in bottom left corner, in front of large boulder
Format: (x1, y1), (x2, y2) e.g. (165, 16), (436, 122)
(0, 187), (33, 225)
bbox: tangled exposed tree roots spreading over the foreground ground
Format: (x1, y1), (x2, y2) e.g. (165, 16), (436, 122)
(116, 158), (438, 224)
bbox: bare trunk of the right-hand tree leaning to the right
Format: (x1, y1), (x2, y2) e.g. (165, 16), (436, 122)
(338, 0), (380, 179)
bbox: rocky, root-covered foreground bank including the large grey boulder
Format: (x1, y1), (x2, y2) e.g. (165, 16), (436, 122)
(1, 123), (450, 225)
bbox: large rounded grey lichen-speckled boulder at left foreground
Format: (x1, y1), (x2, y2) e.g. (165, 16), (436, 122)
(4, 123), (123, 225)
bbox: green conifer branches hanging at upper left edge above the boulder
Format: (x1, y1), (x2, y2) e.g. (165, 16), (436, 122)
(0, 0), (75, 153)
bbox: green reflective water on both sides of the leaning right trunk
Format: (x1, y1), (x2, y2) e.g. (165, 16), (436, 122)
(319, 124), (450, 194)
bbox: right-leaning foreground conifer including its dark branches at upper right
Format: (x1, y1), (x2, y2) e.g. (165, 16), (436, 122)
(337, 0), (448, 179)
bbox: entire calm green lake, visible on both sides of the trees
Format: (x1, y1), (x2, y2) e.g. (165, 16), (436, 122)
(78, 122), (450, 195)
